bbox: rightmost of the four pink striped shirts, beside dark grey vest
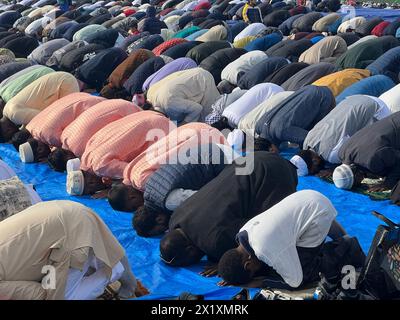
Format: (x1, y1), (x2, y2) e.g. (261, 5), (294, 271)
(123, 122), (226, 190)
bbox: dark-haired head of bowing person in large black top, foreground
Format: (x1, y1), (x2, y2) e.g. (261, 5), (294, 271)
(160, 229), (204, 266)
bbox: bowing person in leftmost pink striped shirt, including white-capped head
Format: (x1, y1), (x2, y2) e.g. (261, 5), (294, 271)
(18, 92), (104, 162)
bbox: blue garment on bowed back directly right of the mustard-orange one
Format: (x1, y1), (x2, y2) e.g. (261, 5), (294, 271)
(336, 75), (395, 104)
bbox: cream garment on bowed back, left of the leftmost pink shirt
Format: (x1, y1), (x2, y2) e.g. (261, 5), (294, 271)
(3, 72), (79, 125)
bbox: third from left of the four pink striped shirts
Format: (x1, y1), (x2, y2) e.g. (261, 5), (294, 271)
(80, 111), (175, 179)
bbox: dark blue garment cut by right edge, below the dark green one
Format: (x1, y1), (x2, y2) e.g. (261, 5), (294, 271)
(366, 47), (400, 83)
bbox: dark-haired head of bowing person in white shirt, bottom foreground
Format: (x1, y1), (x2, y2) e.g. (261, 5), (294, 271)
(218, 249), (251, 284)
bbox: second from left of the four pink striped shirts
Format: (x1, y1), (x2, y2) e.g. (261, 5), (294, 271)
(61, 99), (140, 158)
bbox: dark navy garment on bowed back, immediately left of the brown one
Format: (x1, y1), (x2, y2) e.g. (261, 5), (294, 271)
(75, 48), (128, 91)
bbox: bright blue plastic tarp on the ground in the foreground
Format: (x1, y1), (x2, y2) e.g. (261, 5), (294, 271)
(0, 144), (400, 299)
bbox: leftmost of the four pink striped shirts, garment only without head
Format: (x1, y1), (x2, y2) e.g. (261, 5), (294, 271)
(26, 92), (104, 147)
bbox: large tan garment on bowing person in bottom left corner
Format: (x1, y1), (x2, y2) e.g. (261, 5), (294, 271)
(0, 200), (124, 300)
